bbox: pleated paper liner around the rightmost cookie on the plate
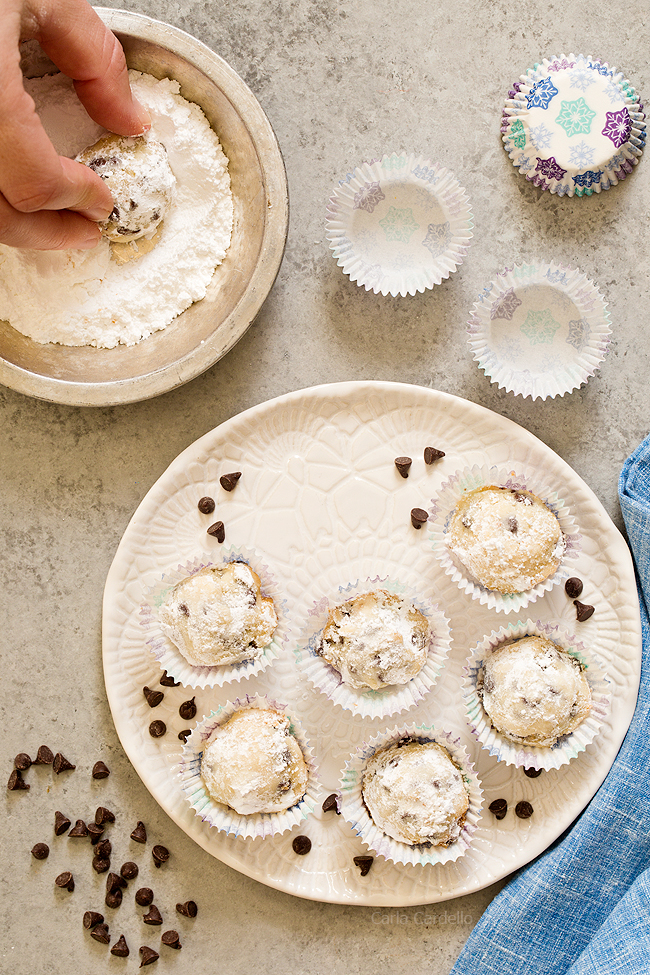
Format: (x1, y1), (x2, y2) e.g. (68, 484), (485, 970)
(463, 619), (610, 771)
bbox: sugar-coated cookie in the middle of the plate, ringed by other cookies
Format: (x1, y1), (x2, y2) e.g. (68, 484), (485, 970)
(317, 589), (429, 690)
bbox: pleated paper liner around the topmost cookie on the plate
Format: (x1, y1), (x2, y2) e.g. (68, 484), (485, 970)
(428, 464), (581, 613)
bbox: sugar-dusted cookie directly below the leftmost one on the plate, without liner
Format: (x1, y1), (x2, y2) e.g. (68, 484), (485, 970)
(201, 708), (309, 816)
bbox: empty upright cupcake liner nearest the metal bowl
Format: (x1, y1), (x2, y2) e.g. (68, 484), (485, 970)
(326, 153), (474, 297)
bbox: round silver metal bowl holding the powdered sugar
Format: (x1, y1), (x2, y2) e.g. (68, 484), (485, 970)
(0, 8), (289, 406)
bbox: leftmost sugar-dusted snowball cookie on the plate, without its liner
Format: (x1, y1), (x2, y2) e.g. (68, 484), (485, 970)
(159, 562), (278, 667)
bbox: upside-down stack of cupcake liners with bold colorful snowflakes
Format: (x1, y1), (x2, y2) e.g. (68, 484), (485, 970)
(501, 54), (646, 197)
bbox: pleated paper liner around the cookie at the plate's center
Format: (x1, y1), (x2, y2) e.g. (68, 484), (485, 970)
(294, 576), (451, 718)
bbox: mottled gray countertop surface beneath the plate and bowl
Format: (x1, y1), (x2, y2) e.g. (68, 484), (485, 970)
(0, 0), (650, 975)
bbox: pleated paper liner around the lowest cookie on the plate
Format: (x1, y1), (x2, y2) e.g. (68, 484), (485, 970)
(340, 724), (483, 866)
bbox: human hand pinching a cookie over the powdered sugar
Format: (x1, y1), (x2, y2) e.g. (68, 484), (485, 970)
(0, 0), (150, 250)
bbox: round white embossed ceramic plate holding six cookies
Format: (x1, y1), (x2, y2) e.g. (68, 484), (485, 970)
(103, 382), (641, 906)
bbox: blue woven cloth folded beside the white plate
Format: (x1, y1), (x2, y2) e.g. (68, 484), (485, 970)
(451, 436), (650, 975)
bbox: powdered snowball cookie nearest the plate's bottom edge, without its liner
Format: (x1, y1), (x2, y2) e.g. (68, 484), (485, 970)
(361, 738), (469, 846)
